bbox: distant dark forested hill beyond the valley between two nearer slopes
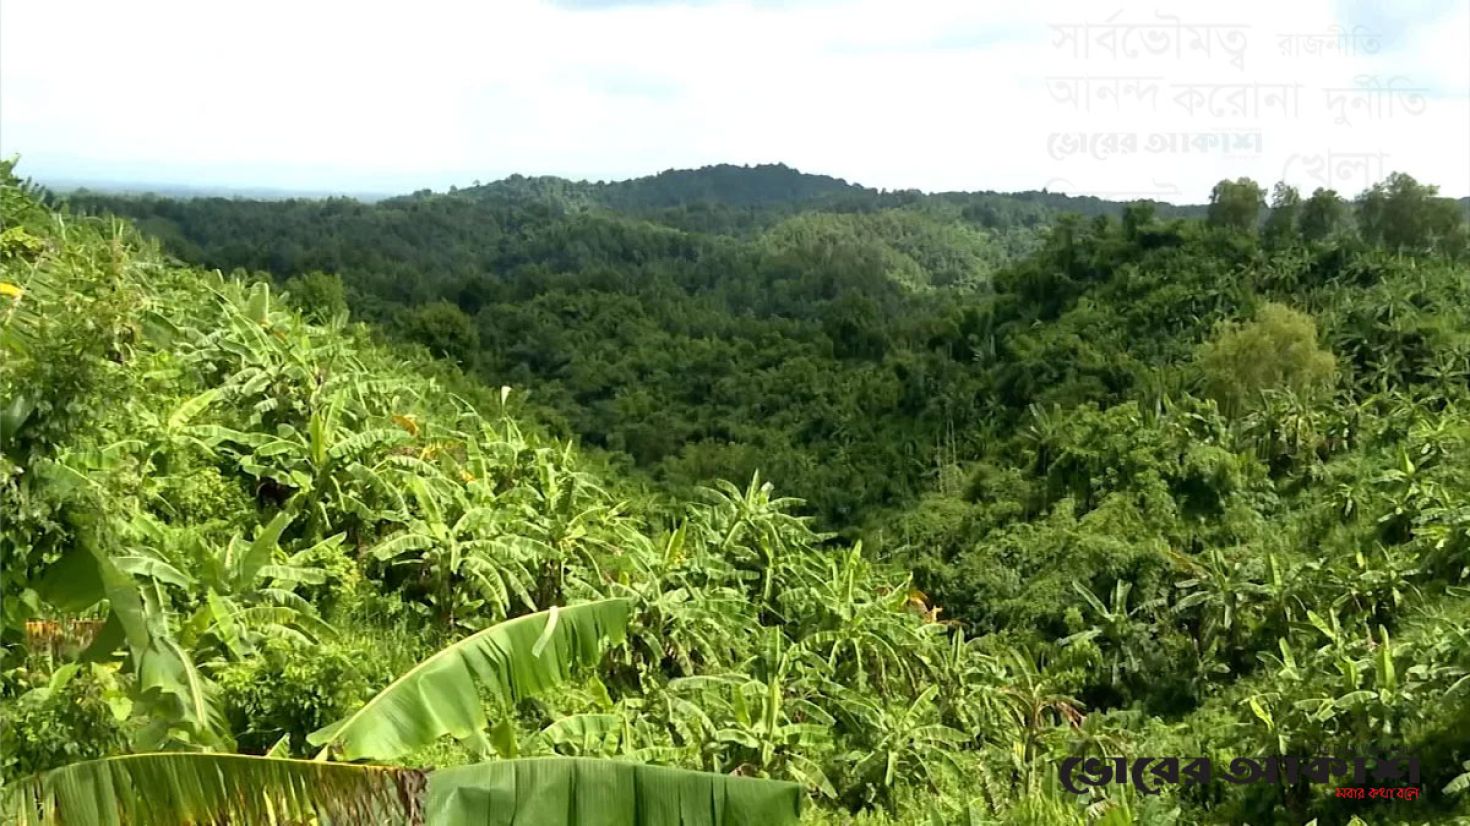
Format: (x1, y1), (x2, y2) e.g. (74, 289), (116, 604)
(60, 166), (1205, 528)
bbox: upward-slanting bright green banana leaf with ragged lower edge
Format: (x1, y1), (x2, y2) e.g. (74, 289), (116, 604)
(307, 600), (632, 761)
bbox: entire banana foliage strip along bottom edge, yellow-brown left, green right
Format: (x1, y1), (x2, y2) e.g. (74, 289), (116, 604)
(0, 753), (803, 826)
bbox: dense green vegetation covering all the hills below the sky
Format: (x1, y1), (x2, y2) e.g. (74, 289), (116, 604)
(0, 157), (1470, 826)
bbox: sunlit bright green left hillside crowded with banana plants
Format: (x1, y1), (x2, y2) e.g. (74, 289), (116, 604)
(0, 168), (1058, 822)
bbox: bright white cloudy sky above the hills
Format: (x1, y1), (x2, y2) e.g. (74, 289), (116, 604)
(0, 0), (1470, 203)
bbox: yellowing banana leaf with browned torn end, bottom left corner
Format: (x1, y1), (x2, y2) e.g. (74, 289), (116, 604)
(0, 753), (426, 826)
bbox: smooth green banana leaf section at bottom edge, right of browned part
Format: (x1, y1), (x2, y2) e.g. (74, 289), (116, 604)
(425, 757), (801, 826)
